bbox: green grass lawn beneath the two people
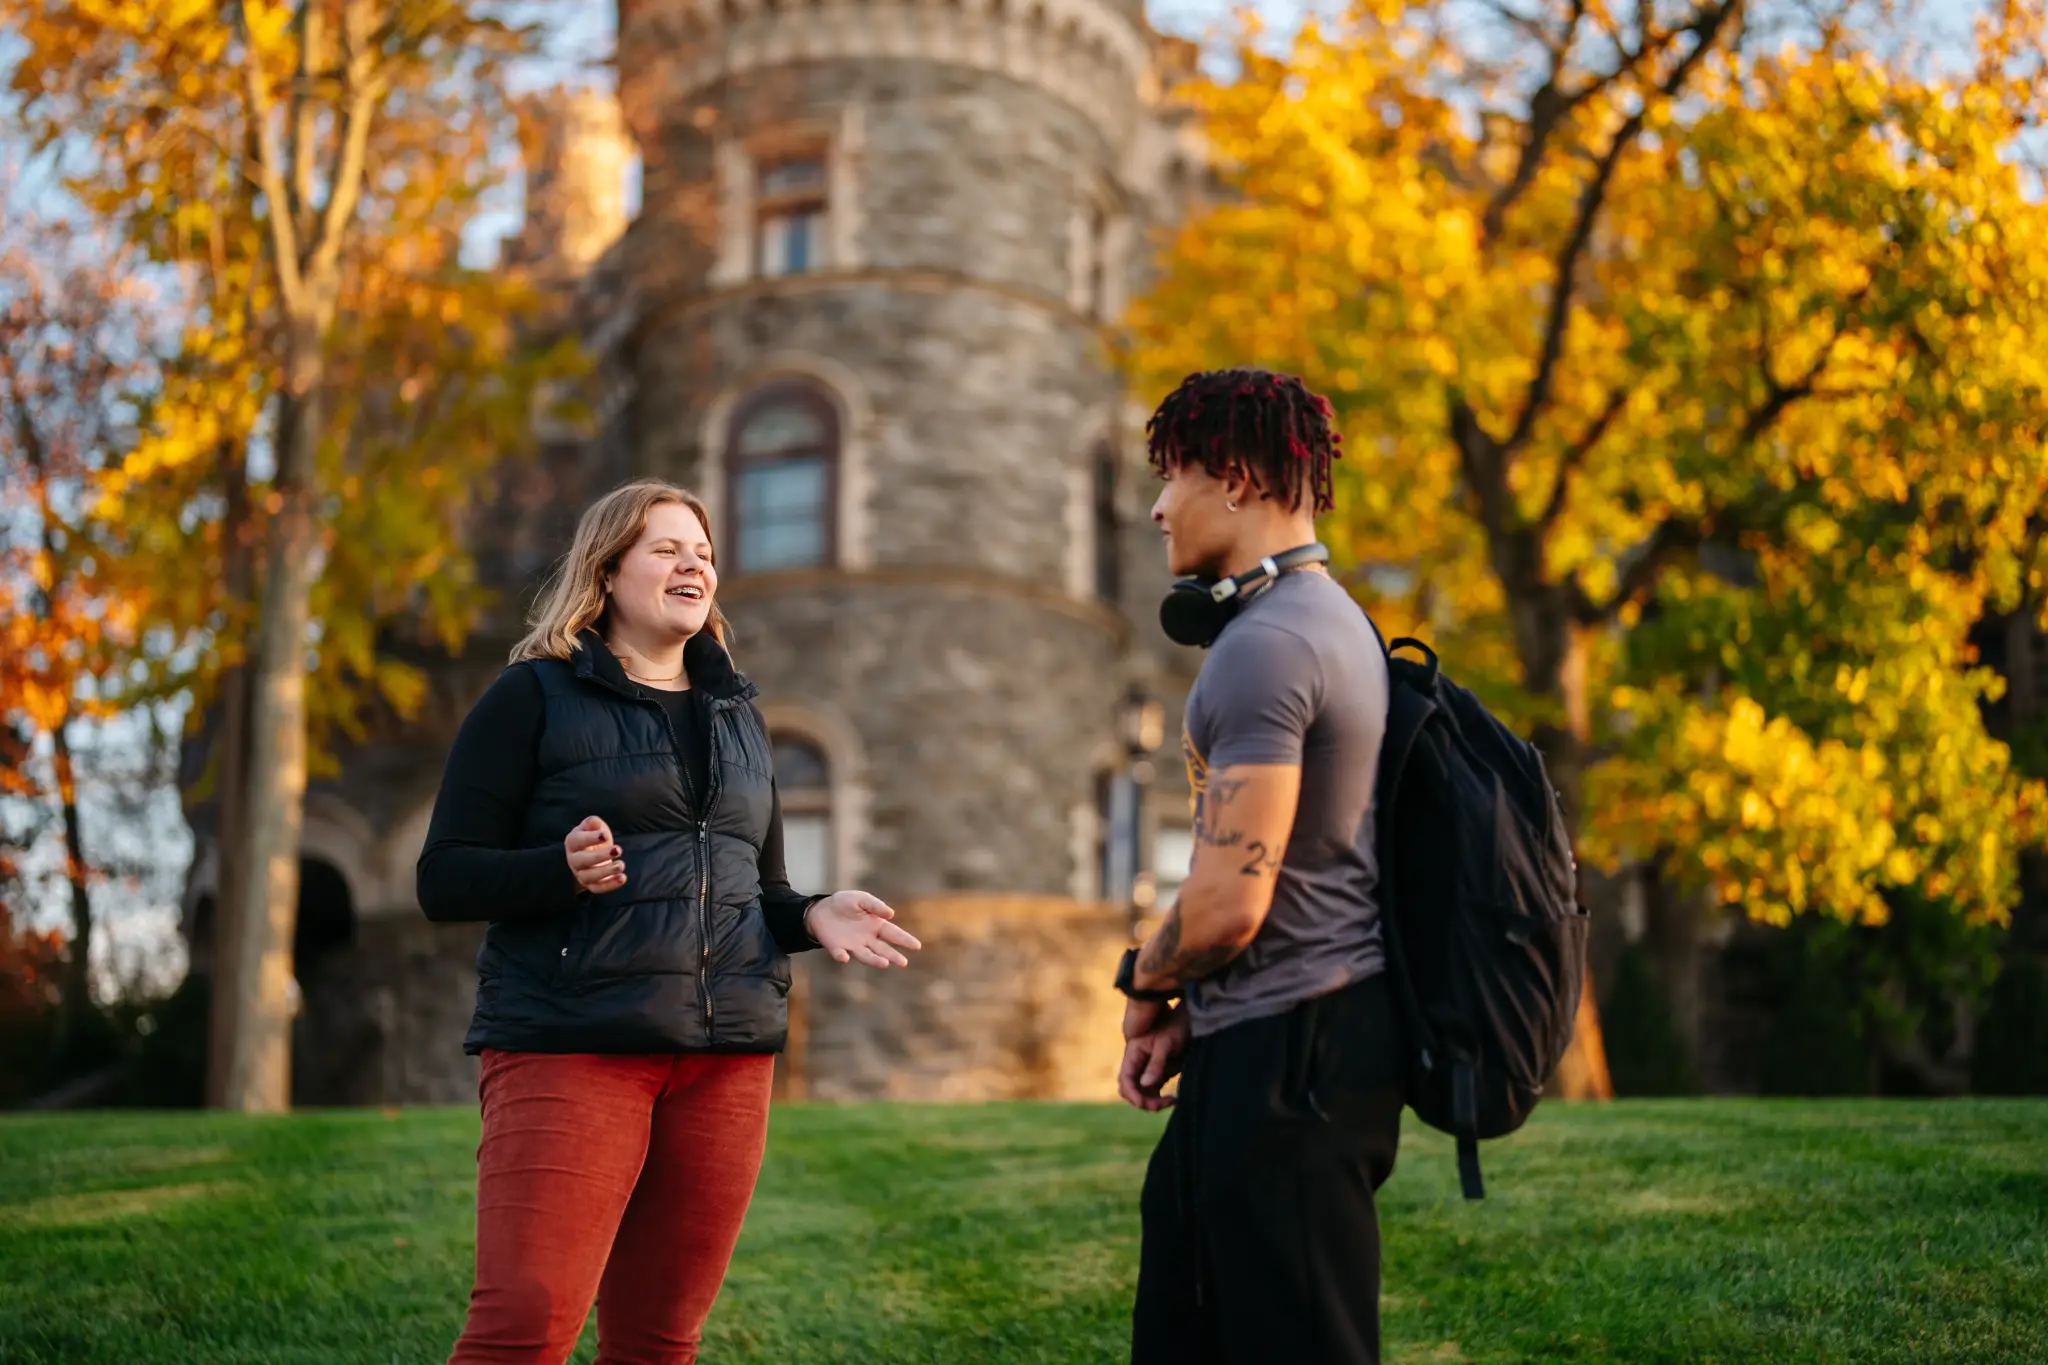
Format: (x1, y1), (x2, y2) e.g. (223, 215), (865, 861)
(0, 1101), (2048, 1365)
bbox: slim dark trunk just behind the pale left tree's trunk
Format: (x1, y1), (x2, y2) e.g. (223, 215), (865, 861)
(207, 444), (254, 1109)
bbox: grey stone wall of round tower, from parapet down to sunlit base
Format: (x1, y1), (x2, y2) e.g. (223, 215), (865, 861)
(637, 50), (1122, 916)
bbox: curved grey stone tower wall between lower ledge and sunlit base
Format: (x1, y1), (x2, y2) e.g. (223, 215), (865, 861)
(721, 579), (1116, 898)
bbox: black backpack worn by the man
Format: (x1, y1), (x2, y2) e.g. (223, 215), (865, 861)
(1374, 626), (1587, 1199)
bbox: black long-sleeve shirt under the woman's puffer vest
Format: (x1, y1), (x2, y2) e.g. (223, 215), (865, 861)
(418, 667), (819, 952)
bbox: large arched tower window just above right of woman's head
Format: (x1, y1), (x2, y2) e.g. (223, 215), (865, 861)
(727, 385), (840, 573)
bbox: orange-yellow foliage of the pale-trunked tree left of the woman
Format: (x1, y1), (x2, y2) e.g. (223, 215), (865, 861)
(0, 0), (575, 769)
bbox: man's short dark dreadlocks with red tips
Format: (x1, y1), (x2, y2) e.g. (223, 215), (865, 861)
(1145, 370), (1343, 512)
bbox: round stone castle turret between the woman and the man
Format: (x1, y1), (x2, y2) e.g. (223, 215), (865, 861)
(618, 0), (1187, 1097)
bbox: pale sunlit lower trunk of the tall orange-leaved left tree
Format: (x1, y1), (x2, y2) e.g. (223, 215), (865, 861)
(223, 382), (319, 1111)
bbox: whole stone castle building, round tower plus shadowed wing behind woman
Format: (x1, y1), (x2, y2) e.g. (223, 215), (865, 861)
(195, 0), (1196, 1101)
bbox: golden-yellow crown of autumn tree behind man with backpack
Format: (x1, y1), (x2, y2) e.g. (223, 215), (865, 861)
(1130, 0), (2048, 1096)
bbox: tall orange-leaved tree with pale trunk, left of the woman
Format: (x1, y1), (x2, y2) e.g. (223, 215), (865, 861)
(0, 0), (565, 1109)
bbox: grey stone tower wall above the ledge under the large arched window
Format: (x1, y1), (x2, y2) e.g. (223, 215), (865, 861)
(635, 61), (1118, 581)
